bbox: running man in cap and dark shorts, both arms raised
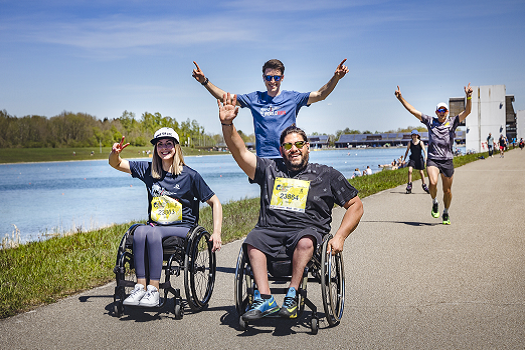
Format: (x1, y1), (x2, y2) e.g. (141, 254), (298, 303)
(395, 83), (472, 225)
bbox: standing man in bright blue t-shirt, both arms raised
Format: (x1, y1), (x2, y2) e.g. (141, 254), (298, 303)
(193, 58), (348, 158)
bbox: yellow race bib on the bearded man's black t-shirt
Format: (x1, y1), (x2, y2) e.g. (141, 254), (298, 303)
(270, 177), (310, 213)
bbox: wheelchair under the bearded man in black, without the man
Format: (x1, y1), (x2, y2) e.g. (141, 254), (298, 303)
(235, 234), (345, 334)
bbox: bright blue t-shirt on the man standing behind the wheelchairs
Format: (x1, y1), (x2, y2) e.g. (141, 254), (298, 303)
(237, 90), (310, 158)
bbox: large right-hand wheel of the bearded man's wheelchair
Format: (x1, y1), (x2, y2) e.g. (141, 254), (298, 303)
(320, 239), (345, 326)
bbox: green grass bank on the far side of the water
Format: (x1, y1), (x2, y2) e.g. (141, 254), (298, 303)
(0, 146), (224, 163)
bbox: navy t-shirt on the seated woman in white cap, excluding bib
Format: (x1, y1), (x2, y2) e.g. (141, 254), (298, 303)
(129, 161), (215, 228)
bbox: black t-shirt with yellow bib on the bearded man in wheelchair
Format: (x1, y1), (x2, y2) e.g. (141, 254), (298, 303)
(251, 157), (358, 234)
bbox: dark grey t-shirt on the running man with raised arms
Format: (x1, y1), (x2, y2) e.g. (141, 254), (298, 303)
(421, 114), (459, 160)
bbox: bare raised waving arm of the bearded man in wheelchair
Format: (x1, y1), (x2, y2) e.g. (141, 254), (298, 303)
(217, 92), (257, 180)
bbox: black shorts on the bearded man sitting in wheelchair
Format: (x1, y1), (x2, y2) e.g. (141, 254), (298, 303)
(243, 227), (323, 259)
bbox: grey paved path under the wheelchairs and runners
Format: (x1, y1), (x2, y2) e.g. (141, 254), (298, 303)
(0, 150), (525, 349)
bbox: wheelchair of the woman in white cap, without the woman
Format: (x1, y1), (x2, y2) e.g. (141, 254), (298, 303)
(113, 217), (216, 320)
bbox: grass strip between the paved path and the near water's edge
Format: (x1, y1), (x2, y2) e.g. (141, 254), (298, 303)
(0, 150), (487, 318)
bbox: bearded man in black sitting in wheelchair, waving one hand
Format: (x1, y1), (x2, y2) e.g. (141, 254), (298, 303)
(217, 93), (363, 321)
